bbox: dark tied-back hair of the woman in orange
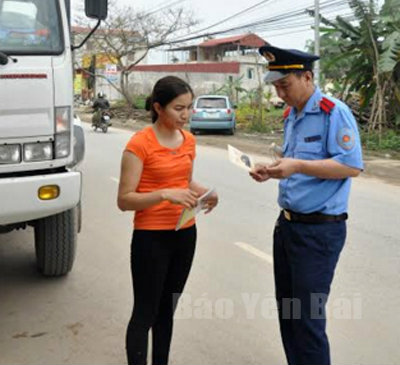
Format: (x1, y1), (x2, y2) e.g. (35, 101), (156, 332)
(146, 76), (193, 123)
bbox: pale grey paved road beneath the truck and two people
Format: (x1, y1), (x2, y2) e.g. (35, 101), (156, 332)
(0, 123), (400, 364)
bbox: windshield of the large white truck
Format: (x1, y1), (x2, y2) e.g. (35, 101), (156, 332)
(0, 0), (63, 54)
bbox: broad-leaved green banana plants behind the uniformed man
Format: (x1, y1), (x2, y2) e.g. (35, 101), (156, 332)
(312, 0), (400, 135)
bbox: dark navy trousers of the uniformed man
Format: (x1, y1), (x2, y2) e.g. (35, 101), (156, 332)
(274, 216), (346, 365)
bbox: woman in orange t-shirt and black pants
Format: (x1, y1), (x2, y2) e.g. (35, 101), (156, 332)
(118, 76), (218, 365)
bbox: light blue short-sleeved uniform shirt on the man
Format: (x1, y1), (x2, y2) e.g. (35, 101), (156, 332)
(278, 88), (363, 215)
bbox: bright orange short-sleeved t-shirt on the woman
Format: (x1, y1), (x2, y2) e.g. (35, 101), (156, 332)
(125, 127), (196, 230)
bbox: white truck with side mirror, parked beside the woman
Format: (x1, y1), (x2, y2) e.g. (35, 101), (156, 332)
(0, 0), (108, 276)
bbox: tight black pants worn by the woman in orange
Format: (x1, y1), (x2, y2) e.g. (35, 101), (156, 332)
(126, 226), (196, 365)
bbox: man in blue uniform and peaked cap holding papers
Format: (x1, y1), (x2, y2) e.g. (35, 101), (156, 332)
(250, 46), (363, 365)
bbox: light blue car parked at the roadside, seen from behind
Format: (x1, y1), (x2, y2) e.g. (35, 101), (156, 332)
(190, 95), (236, 135)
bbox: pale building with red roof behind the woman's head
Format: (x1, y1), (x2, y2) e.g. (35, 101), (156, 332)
(129, 33), (267, 101)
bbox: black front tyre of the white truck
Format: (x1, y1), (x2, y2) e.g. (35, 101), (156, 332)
(35, 208), (78, 276)
